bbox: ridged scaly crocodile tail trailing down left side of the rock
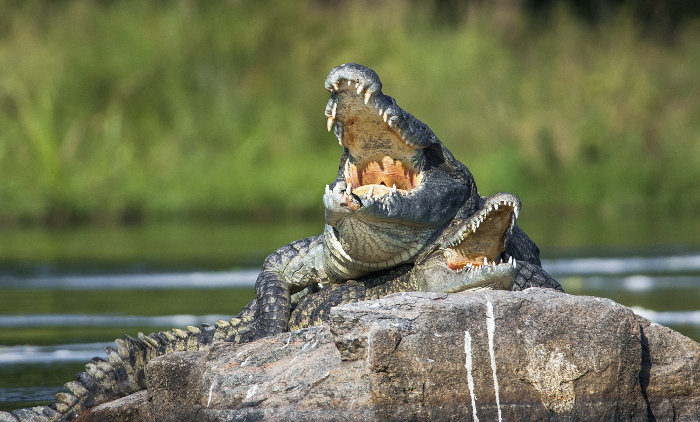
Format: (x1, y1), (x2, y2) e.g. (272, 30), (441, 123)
(0, 300), (256, 422)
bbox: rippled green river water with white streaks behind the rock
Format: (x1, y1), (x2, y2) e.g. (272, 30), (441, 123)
(0, 221), (700, 410)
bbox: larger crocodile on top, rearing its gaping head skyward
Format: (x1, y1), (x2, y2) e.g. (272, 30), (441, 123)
(254, 63), (541, 337)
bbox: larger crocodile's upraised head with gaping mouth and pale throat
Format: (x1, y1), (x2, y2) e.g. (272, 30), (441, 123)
(324, 63), (476, 279)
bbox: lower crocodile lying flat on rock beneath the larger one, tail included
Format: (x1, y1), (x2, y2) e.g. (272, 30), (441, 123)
(0, 193), (563, 421)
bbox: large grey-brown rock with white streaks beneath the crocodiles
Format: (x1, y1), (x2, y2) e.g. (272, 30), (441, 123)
(81, 289), (700, 421)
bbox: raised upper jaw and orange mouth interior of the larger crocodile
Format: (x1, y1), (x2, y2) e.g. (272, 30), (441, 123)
(326, 64), (439, 200)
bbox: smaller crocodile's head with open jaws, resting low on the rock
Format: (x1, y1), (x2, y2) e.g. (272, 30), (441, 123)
(411, 193), (520, 293)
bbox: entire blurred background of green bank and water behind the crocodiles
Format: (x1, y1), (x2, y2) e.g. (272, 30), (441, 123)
(0, 0), (700, 409)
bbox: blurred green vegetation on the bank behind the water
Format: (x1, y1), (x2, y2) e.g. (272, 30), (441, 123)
(0, 0), (700, 224)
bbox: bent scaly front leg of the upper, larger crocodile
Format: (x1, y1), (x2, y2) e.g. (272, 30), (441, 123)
(255, 236), (327, 338)
